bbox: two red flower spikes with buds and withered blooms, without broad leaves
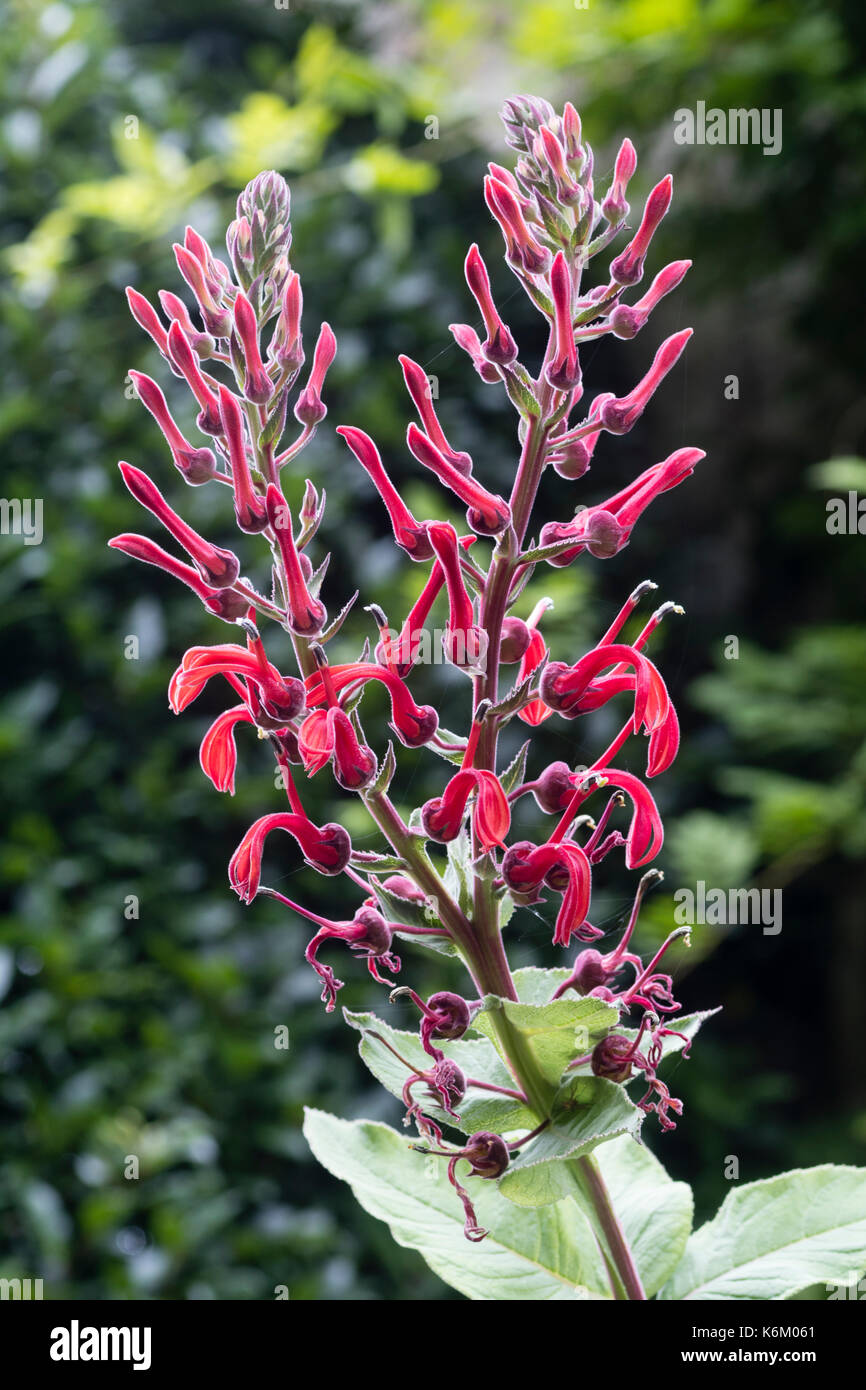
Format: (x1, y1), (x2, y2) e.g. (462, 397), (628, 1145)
(110, 97), (703, 1240)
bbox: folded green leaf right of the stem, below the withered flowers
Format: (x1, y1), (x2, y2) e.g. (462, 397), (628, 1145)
(499, 1076), (644, 1207)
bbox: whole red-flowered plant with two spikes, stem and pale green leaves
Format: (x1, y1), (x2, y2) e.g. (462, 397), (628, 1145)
(110, 97), (866, 1300)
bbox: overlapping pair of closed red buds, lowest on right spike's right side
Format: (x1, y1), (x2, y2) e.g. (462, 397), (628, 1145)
(541, 449), (706, 566)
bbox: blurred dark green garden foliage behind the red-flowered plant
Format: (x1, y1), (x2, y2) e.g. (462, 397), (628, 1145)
(0, 0), (866, 1300)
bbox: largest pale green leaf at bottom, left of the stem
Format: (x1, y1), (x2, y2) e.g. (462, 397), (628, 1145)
(304, 1109), (603, 1302)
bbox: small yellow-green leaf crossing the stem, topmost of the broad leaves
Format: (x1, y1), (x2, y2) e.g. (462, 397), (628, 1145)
(473, 989), (620, 1084)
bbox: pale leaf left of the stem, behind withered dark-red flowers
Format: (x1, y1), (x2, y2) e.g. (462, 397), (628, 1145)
(343, 1005), (538, 1134)
